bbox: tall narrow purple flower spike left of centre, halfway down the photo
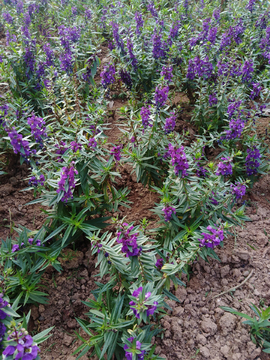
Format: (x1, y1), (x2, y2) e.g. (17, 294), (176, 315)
(56, 163), (78, 202)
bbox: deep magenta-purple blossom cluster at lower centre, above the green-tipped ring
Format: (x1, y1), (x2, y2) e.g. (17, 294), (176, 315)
(117, 223), (142, 257)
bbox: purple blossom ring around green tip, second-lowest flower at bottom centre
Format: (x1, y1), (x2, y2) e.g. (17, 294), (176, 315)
(129, 286), (158, 319)
